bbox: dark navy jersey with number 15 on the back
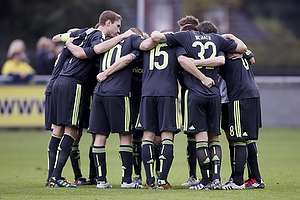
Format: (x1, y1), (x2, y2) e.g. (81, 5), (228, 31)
(142, 43), (186, 97)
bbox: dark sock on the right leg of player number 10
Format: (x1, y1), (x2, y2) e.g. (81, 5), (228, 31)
(119, 145), (133, 183)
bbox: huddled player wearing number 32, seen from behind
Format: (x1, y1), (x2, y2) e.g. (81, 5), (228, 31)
(151, 22), (247, 190)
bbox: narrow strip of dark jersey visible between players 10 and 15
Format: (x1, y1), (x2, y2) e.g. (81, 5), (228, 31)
(130, 54), (143, 106)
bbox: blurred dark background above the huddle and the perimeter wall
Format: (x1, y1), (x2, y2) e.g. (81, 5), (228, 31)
(0, 0), (300, 76)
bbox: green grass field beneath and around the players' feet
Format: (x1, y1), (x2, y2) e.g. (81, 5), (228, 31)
(0, 128), (300, 200)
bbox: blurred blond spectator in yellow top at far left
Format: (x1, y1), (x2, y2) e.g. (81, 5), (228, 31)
(1, 39), (35, 82)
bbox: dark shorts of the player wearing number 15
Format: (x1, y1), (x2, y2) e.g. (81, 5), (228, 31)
(136, 96), (180, 134)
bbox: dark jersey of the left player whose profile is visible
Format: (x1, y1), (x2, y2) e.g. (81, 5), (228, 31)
(60, 30), (103, 81)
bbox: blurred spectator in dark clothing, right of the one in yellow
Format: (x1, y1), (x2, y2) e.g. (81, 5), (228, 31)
(35, 36), (56, 75)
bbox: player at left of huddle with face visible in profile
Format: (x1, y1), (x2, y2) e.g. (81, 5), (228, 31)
(50, 11), (131, 187)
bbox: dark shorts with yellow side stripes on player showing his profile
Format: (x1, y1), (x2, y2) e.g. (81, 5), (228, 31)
(50, 77), (84, 128)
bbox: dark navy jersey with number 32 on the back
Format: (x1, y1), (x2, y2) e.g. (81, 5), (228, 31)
(165, 31), (237, 98)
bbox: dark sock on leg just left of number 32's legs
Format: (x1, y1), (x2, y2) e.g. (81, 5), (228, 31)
(186, 137), (197, 179)
